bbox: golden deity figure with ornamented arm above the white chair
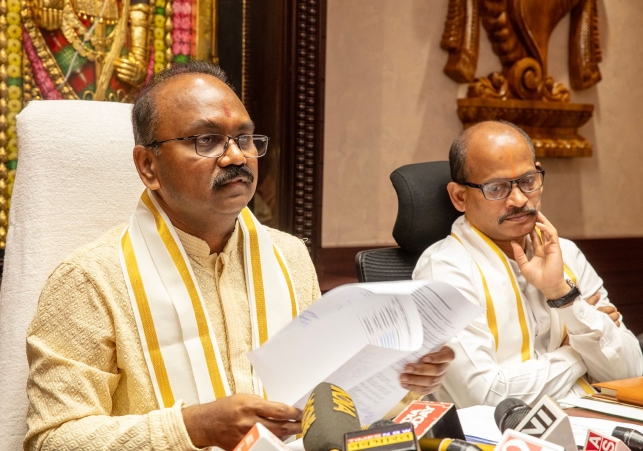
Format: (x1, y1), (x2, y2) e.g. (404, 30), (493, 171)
(22, 0), (155, 101)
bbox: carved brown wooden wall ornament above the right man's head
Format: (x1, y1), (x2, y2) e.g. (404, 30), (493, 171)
(441, 0), (601, 157)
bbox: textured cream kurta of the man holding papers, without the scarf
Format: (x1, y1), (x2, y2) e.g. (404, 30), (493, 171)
(25, 224), (320, 450)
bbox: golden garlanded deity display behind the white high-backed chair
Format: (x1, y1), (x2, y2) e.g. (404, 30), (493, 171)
(0, 0), (217, 250)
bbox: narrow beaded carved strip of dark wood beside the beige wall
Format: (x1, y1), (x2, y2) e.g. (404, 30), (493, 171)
(282, 0), (326, 258)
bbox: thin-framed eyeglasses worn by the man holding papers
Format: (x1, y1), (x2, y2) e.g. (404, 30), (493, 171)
(146, 133), (270, 158)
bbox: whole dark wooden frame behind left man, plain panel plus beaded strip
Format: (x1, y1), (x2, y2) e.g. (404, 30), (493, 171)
(239, 0), (326, 258)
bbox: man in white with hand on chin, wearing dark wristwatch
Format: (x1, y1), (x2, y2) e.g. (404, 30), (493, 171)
(413, 122), (643, 407)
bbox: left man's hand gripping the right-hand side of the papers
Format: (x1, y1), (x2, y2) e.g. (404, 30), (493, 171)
(400, 346), (455, 396)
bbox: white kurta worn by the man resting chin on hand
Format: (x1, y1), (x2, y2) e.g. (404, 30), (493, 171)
(413, 216), (643, 407)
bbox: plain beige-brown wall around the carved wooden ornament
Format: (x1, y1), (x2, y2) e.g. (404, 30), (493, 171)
(322, 0), (643, 247)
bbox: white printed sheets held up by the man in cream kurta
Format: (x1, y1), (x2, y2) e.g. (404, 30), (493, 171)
(248, 281), (484, 424)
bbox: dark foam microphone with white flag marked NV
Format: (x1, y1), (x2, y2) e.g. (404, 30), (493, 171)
(494, 395), (577, 451)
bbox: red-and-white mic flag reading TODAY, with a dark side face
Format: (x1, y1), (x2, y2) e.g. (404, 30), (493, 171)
(393, 401), (465, 440)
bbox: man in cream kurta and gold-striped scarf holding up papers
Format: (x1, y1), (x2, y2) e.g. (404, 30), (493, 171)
(25, 61), (452, 451)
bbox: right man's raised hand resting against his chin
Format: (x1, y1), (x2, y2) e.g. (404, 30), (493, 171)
(511, 212), (570, 299)
